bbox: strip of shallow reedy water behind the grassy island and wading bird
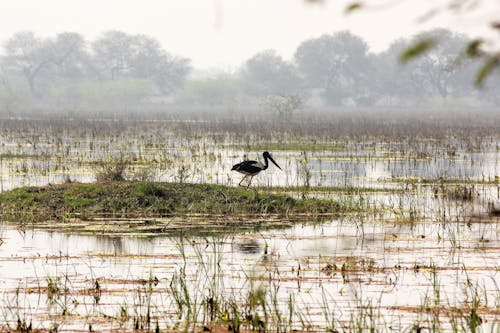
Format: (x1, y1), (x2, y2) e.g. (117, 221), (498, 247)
(0, 133), (500, 191)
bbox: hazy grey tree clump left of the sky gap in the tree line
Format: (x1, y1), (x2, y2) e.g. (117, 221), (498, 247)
(0, 31), (191, 106)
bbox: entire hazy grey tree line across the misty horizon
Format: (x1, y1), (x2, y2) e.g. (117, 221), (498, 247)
(0, 29), (500, 109)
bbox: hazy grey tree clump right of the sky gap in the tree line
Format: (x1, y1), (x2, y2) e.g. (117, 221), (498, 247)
(200, 29), (500, 106)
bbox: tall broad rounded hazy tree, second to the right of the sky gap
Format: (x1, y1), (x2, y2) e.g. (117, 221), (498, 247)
(295, 31), (376, 105)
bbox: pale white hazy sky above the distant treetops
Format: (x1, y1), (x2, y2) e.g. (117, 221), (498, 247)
(0, 0), (500, 70)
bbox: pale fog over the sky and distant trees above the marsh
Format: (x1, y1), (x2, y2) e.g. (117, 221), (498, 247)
(0, 0), (500, 117)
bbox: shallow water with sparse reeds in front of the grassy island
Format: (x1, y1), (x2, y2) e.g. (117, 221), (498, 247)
(0, 205), (500, 330)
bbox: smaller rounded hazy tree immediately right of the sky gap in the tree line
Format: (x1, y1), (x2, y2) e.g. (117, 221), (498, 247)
(241, 50), (303, 97)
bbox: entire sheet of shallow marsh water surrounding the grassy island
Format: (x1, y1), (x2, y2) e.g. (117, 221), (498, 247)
(0, 127), (500, 331)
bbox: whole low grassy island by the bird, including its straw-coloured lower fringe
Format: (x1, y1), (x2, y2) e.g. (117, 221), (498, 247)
(0, 181), (347, 233)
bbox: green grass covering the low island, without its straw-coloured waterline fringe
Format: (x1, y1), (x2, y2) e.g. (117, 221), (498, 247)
(0, 181), (351, 223)
